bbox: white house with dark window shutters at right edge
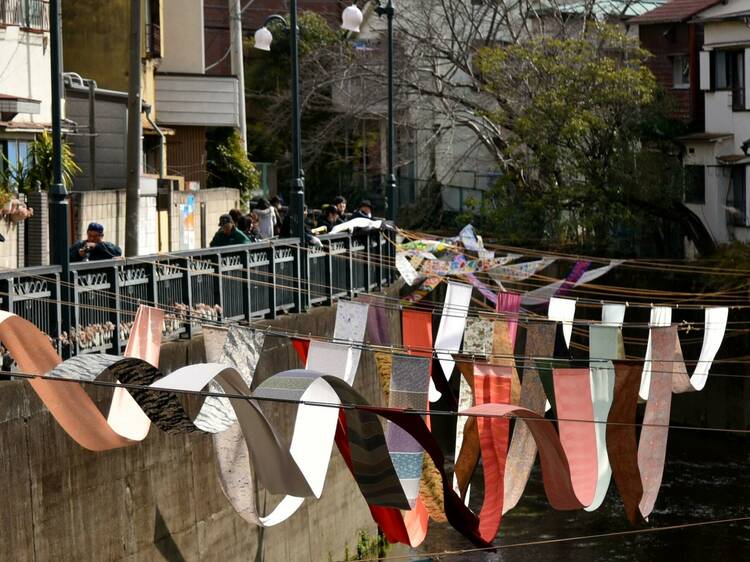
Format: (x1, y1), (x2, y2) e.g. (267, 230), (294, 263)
(681, 0), (750, 243)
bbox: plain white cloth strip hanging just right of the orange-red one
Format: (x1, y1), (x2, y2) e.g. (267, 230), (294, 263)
(429, 283), (472, 402)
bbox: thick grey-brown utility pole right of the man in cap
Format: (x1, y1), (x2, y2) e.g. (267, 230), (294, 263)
(125, 0), (143, 256)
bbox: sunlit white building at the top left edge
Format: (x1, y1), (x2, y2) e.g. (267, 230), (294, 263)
(0, 0), (52, 177)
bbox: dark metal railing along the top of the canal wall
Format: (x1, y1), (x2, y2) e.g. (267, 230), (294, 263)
(0, 230), (395, 356)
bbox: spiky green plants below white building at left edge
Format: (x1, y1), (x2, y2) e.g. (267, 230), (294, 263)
(0, 131), (81, 192)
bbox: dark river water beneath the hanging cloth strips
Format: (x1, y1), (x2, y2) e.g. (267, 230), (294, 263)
(396, 430), (750, 562)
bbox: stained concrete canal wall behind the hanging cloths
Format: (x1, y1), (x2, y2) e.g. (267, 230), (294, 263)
(0, 302), (397, 562)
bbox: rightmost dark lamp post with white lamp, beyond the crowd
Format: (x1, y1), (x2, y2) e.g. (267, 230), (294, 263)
(341, 0), (398, 221)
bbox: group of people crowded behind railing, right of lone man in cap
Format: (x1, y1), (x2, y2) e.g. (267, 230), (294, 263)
(210, 195), (372, 248)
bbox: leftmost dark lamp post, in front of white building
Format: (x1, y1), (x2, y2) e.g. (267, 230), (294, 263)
(49, 0), (70, 331)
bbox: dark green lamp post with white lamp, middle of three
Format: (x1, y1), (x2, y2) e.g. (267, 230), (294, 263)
(255, 0), (306, 245)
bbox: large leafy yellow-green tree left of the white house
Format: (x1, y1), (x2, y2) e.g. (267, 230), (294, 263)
(475, 26), (692, 250)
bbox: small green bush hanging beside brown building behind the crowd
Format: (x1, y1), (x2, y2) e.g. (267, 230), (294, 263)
(206, 128), (260, 204)
